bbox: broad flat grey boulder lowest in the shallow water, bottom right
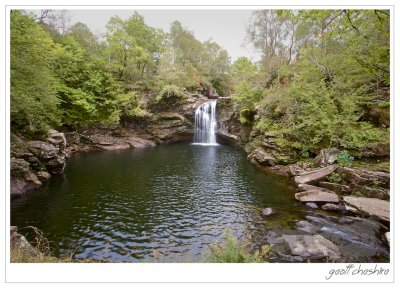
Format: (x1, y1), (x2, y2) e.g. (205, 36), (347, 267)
(282, 235), (340, 260)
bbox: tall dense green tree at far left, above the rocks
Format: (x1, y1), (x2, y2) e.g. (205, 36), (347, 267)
(10, 10), (61, 134)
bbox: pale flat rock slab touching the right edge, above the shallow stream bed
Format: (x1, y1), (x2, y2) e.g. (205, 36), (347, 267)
(343, 196), (390, 221)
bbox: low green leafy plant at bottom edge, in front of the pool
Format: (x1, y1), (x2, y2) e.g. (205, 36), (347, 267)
(207, 229), (271, 263)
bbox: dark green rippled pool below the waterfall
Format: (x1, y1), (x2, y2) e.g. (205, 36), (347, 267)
(11, 144), (304, 262)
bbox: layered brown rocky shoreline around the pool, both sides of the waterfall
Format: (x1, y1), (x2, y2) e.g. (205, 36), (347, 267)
(11, 95), (390, 262)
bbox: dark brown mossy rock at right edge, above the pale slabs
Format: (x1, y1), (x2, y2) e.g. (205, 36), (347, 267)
(338, 167), (390, 189)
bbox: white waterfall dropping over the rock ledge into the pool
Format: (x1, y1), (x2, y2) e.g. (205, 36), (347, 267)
(193, 100), (218, 145)
